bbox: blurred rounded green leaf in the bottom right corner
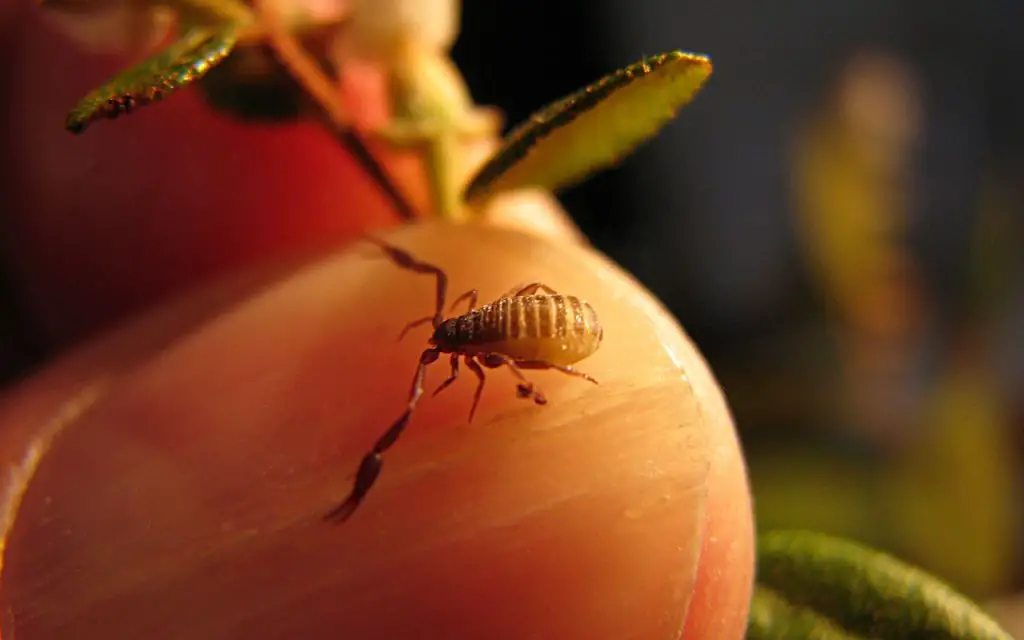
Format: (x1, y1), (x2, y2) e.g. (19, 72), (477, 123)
(749, 531), (1012, 640)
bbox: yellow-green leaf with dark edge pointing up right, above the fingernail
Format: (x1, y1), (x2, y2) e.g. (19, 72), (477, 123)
(465, 51), (712, 205)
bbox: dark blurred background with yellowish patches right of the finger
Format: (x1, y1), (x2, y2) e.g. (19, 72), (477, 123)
(0, 0), (1024, 630)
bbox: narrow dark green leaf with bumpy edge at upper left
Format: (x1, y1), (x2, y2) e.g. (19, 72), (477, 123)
(66, 25), (241, 133)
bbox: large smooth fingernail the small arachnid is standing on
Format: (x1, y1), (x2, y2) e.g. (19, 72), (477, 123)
(0, 223), (753, 640)
